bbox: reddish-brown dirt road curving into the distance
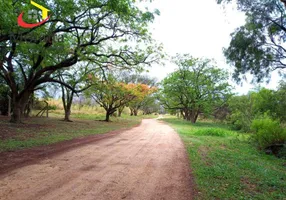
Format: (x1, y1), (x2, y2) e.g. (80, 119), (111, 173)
(0, 119), (192, 200)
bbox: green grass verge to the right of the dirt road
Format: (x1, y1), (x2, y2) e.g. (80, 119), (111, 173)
(163, 118), (286, 200)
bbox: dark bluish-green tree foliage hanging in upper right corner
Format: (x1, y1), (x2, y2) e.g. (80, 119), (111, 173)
(217, 0), (286, 82)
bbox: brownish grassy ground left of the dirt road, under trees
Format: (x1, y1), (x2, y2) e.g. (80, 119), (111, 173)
(0, 111), (155, 152)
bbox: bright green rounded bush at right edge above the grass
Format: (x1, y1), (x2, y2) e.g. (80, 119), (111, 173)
(251, 116), (286, 149)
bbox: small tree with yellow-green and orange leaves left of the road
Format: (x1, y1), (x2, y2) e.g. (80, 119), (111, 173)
(86, 74), (136, 122)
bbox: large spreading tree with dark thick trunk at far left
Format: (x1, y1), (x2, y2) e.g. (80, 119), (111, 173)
(0, 0), (160, 123)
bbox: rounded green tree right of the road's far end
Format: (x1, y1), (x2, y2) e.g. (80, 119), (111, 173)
(159, 54), (230, 123)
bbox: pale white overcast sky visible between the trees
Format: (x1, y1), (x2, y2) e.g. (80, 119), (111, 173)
(140, 0), (280, 94)
